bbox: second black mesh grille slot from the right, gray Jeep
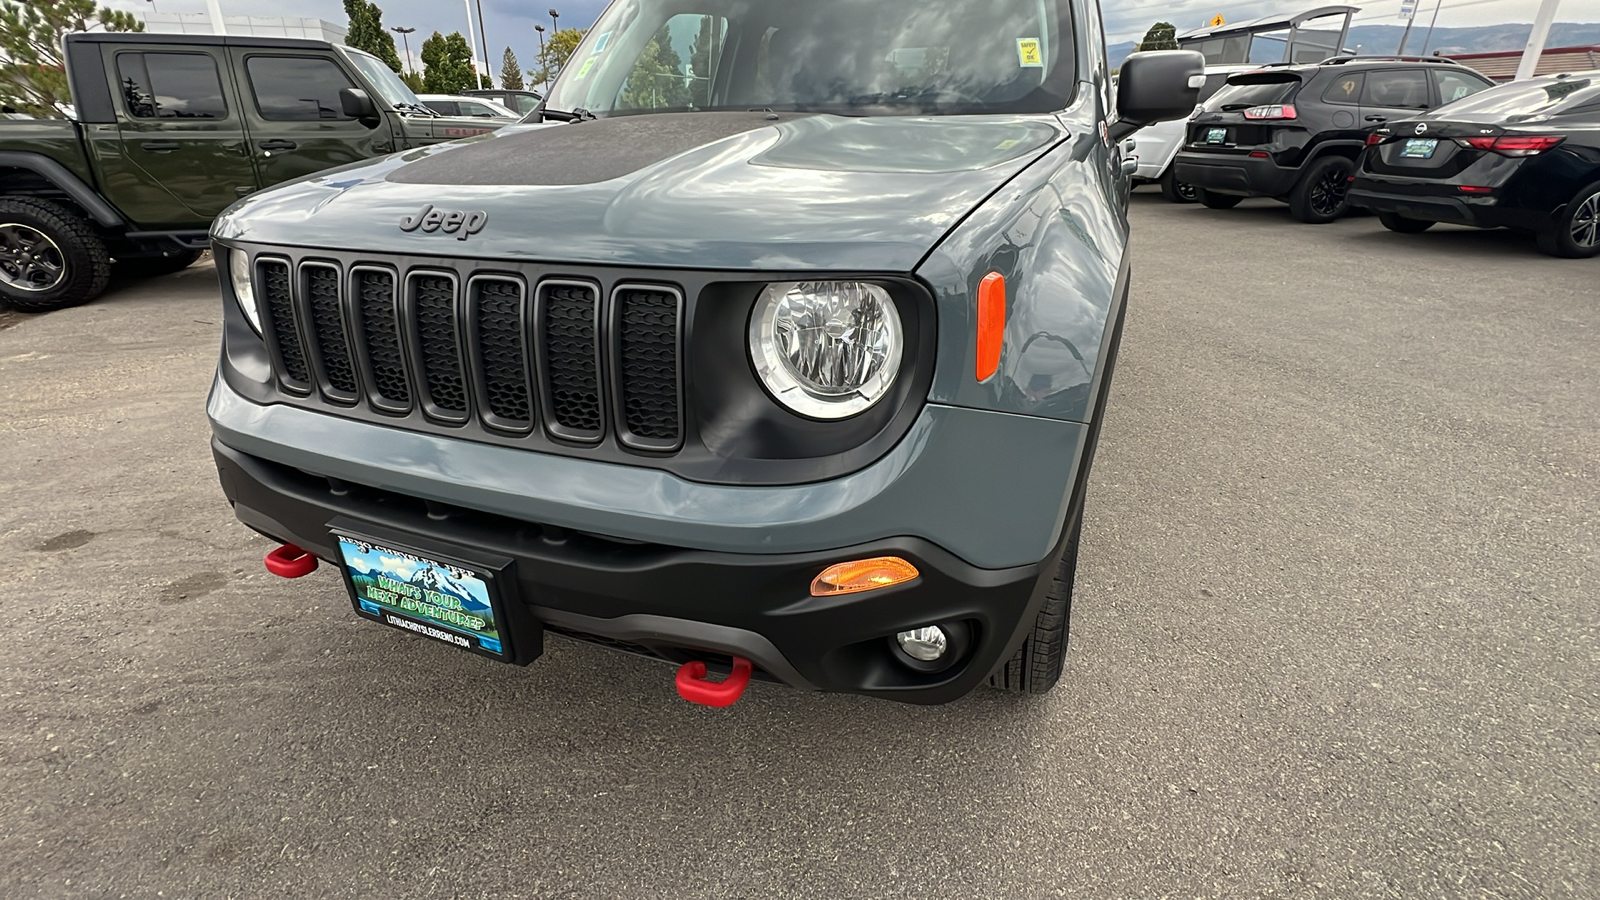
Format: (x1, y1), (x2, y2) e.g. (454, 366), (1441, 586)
(539, 282), (600, 440)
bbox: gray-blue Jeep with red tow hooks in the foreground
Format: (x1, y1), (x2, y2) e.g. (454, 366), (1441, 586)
(208, 0), (1203, 705)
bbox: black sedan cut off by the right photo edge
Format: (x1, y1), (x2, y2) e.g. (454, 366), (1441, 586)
(1350, 70), (1600, 258)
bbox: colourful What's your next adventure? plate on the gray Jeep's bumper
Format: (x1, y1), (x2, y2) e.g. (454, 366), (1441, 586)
(334, 533), (510, 661)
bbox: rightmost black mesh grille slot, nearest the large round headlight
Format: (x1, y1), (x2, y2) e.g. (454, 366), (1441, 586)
(616, 287), (682, 450)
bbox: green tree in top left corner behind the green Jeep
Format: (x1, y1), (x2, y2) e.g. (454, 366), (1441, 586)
(0, 0), (144, 119)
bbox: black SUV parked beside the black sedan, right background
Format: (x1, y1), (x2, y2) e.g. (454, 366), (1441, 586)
(1173, 56), (1493, 224)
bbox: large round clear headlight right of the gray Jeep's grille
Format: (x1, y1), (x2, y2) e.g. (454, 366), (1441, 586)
(750, 282), (904, 420)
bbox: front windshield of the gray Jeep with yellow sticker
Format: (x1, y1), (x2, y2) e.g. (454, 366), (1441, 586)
(549, 0), (1077, 115)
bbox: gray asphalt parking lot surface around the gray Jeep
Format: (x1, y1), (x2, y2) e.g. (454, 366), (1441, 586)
(0, 201), (1600, 898)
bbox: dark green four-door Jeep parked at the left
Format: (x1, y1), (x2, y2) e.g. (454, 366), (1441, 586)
(0, 34), (505, 312)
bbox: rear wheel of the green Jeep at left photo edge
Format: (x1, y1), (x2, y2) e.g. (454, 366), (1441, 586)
(0, 197), (110, 312)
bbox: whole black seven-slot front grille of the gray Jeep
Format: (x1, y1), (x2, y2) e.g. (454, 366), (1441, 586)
(256, 256), (683, 453)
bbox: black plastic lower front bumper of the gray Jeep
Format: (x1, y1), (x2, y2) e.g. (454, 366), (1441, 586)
(213, 440), (1053, 703)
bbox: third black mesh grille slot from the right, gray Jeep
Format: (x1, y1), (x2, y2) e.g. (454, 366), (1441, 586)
(470, 279), (533, 431)
